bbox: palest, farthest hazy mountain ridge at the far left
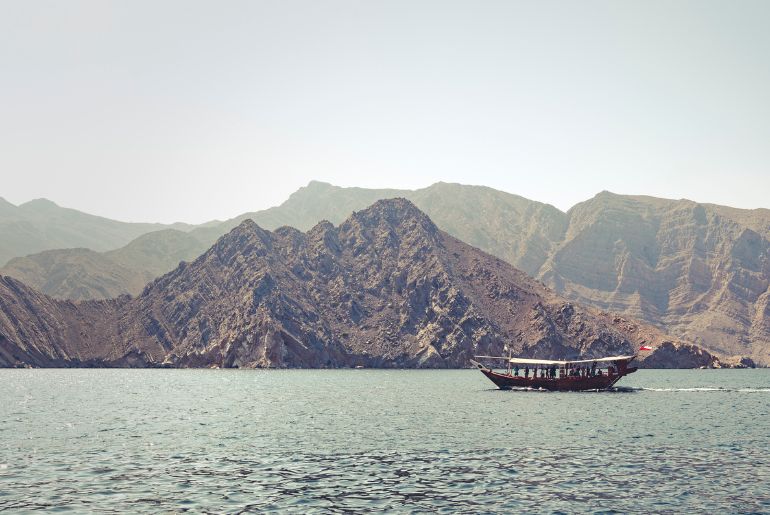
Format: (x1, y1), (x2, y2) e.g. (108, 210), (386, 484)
(0, 198), (202, 265)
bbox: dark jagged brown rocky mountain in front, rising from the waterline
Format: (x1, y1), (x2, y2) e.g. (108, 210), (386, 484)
(0, 199), (712, 367)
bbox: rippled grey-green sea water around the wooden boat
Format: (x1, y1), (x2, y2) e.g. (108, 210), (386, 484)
(0, 369), (770, 513)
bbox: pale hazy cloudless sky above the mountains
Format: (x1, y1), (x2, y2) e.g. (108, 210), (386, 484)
(0, 0), (770, 222)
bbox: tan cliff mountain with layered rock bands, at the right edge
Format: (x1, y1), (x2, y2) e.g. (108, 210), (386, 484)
(538, 192), (770, 364)
